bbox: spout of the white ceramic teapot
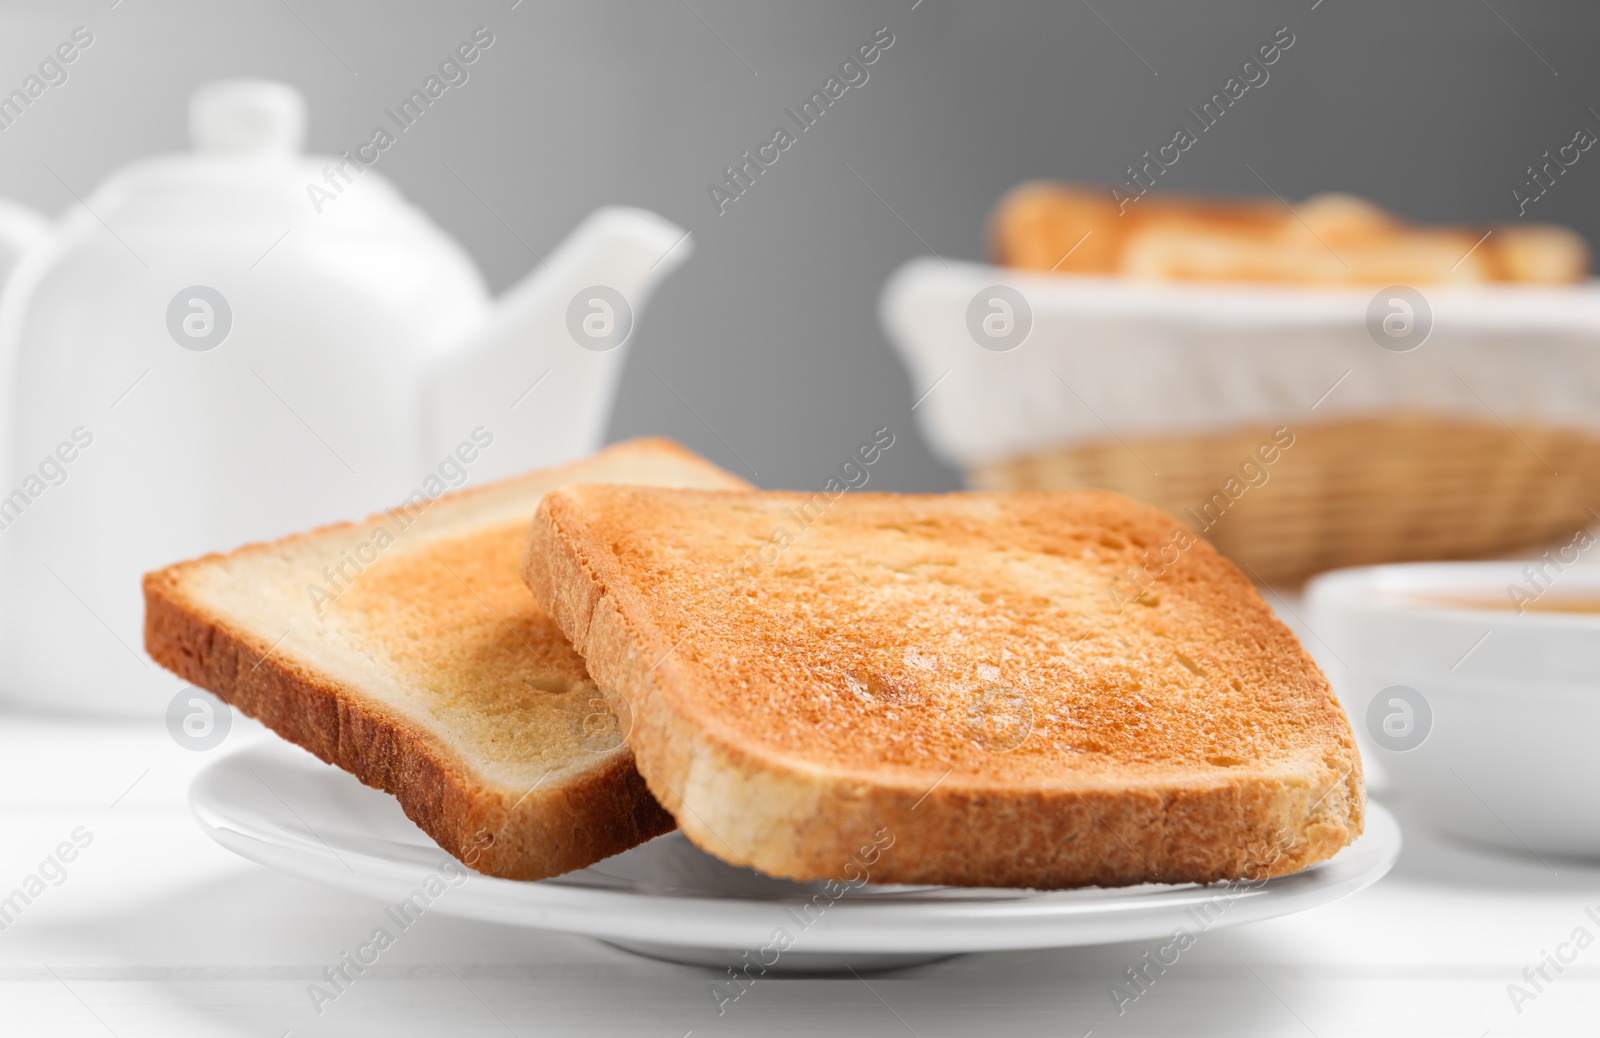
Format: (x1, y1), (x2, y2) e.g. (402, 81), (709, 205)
(422, 206), (693, 483)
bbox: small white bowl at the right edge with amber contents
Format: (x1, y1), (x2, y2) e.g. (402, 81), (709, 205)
(1306, 562), (1600, 856)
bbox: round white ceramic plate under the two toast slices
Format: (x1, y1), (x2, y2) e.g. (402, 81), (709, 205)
(189, 742), (1400, 972)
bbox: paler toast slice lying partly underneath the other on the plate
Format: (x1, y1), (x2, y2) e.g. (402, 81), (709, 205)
(144, 440), (746, 880)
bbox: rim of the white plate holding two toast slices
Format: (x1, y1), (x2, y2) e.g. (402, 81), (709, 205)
(189, 742), (1403, 953)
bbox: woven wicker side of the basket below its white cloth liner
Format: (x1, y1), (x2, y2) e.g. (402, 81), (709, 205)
(968, 414), (1600, 584)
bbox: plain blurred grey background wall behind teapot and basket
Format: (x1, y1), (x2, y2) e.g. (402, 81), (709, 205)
(0, 0), (1600, 489)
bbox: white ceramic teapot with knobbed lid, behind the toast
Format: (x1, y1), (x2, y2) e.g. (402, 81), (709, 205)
(0, 80), (691, 713)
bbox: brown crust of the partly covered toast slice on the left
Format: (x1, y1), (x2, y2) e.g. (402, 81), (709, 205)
(144, 440), (742, 880)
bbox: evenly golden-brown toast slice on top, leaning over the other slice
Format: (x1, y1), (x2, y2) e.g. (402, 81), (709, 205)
(525, 486), (1365, 888)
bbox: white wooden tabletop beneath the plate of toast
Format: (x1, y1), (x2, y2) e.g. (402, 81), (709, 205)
(0, 715), (1600, 1038)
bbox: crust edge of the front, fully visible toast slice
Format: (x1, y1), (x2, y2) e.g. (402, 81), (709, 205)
(523, 488), (1365, 888)
